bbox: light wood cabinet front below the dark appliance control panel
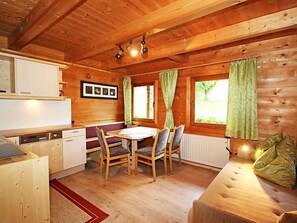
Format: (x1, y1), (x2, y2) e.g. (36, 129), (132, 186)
(20, 139), (63, 174)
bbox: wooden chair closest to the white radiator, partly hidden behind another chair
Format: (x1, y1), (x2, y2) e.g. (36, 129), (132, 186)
(166, 125), (185, 172)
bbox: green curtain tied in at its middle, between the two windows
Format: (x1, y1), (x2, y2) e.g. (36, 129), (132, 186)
(160, 70), (178, 129)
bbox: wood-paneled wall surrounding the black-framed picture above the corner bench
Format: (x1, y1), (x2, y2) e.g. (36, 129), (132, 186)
(63, 67), (124, 124)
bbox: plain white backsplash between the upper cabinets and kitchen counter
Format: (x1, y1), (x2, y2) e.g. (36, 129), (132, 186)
(0, 99), (71, 130)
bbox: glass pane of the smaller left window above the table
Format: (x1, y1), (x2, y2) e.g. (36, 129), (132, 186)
(133, 84), (154, 119)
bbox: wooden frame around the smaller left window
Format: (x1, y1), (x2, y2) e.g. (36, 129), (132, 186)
(132, 82), (158, 123)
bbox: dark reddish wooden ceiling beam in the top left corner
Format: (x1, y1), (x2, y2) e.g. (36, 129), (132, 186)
(9, 0), (86, 50)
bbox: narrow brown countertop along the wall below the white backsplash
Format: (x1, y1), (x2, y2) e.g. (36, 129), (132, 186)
(0, 124), (85, 138)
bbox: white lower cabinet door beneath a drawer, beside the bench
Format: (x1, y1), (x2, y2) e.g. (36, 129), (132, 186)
(63, 135), (86, 170)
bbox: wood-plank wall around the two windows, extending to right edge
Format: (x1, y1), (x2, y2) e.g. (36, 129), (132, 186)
(132, 31), (297, 150)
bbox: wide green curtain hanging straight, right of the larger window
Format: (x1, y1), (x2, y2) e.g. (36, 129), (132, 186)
(226, 58), (258, 140)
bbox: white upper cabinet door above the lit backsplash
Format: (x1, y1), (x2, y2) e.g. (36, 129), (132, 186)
(15, 59), (59, 97)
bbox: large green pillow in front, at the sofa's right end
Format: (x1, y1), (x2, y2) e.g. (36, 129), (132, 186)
(253, 136), (297, 189)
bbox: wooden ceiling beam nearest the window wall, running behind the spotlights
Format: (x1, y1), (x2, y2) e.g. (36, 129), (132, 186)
(102, 8), (297, 70)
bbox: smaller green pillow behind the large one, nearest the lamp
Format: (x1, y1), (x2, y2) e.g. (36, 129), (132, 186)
(250, 133), (283, 161)
